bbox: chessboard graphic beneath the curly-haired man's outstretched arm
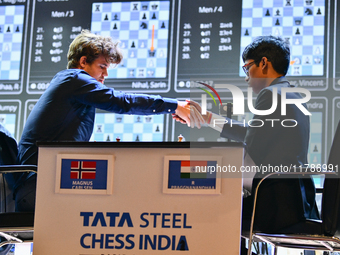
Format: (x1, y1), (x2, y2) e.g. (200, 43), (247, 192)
(90, 113), (164, 142)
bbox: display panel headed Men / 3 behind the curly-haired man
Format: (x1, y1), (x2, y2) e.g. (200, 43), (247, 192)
(27, 0), (173, 94)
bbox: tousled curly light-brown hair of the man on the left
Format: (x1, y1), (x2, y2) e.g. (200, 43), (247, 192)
(67, 30), (123, 69)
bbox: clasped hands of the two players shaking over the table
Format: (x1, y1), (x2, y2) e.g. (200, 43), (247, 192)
(172, 100), (212, 128)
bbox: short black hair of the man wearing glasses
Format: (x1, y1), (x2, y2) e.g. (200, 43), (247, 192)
(242, 35), (290, 75)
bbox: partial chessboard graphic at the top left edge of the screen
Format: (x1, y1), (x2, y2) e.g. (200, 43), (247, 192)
(0, 5), (25, 80)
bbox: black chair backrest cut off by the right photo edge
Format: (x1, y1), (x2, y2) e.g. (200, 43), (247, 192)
(321, 121), (340, 237)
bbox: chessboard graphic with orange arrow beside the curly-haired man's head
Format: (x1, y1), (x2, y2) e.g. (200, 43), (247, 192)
(91, 1), (170, 79)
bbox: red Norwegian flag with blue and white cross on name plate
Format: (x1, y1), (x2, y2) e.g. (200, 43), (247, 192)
(70, 161), (97, 180)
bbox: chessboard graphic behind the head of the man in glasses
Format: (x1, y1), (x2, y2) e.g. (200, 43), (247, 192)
(239, 0), (325, 77)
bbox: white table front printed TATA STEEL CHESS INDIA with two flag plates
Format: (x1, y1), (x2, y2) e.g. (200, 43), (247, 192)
(33, 142), (243, 255)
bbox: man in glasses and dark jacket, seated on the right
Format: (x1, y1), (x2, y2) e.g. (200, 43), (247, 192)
(179, 36), (319, 232)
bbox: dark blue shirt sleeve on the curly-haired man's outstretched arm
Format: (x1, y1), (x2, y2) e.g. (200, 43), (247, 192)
(73, 71), (177, 115)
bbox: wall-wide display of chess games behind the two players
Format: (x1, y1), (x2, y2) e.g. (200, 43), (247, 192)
(0, 0), (334, 162)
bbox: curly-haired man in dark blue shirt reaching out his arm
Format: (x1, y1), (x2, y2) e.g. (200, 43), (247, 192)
(14, 30), (204, 211)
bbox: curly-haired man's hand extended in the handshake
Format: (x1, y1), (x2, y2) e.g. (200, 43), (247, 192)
(173, 101), (205, 128)
